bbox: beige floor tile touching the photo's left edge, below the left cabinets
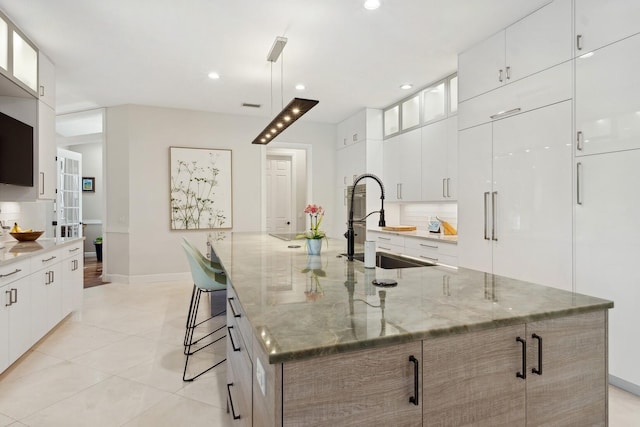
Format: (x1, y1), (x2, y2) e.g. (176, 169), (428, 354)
(0, 361), (109, 420)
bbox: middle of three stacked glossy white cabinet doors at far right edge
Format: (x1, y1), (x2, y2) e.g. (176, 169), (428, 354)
(575, 34), (640, 156)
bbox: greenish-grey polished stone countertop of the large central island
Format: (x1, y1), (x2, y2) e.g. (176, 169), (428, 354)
(209, 232), (613, 363)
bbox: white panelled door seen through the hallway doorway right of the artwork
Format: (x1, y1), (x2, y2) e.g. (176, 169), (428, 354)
(267, 156), (295, 233)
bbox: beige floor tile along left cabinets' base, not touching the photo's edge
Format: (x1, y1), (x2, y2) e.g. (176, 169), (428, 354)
(35, 320), (127, 360)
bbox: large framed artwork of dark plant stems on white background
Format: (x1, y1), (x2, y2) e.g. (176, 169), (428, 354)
(169, 147), (233, 230)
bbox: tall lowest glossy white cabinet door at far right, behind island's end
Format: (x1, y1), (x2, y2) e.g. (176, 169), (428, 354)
(576, 150), (640, 386)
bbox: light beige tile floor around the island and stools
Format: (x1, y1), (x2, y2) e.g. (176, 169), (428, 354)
(0, 282), (640, 427)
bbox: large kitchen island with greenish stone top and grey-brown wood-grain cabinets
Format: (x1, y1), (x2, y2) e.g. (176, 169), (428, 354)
(209, 233), (613, 426)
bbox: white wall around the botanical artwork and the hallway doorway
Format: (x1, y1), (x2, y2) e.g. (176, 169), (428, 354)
(103, 105), (336, 283)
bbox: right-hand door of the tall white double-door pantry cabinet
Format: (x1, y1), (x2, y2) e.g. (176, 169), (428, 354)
(492, 101), (573, 290)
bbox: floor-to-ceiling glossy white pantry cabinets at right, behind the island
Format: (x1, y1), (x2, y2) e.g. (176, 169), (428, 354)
(458, 0), (640, 393)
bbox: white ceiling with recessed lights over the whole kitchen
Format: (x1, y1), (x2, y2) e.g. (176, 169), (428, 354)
(0, 0), (549, 123)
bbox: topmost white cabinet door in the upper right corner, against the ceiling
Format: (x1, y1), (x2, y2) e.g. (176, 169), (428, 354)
(575, 0), (640, 56)
